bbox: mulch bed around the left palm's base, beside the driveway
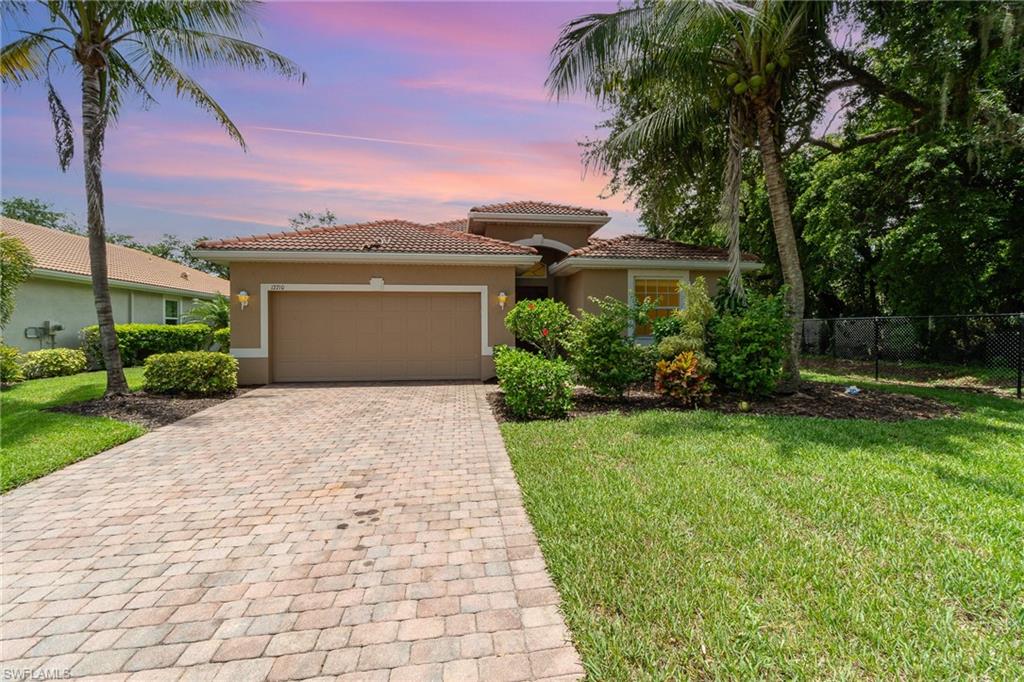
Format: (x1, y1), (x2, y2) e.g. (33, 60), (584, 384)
(50, 388), (250, 429)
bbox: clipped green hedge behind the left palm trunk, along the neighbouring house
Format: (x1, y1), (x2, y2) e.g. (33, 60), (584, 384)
(82, 324), (211, 368)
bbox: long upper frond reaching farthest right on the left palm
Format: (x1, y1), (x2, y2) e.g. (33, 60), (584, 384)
(137, 28), (306, 82)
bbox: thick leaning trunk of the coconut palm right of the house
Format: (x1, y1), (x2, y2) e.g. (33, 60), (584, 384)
(755, 101), (804, 391)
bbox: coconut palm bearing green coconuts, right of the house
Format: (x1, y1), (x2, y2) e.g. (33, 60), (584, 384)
(548, 0), (828, 387)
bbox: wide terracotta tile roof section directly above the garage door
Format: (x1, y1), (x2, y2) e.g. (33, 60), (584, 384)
(194, 220), (537, 256)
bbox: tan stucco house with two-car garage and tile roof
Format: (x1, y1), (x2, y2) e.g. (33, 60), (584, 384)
(196, 202), (761, 384)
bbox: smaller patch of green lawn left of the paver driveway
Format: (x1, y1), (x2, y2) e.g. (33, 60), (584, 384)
(0, 368), (145, 493)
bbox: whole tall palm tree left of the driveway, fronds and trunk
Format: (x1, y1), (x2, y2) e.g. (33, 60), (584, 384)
(0, 0), (305, 396)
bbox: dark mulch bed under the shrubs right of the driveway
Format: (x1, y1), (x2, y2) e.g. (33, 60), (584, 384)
(487, 381), (959, 422)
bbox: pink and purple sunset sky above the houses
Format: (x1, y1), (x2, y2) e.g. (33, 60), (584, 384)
(0, 2), (641, 241)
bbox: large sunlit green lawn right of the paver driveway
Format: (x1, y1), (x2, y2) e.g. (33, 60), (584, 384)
(502, 375), (1024, 680)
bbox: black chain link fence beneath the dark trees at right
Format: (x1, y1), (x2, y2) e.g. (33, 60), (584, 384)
(803, 312), (1024, 397)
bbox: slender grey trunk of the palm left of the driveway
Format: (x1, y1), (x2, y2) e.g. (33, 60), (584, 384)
(82, 63), (128, 397)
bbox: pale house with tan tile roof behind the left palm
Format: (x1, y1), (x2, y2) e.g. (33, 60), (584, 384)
(0, 217), (229, 351)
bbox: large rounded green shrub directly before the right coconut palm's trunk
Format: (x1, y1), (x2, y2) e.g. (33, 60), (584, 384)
(710, 292), (792, 395)
